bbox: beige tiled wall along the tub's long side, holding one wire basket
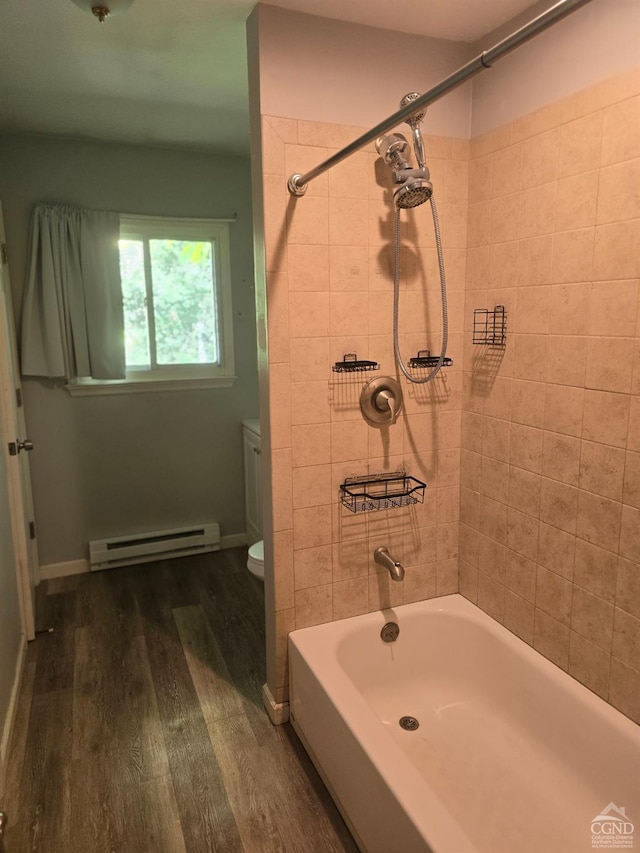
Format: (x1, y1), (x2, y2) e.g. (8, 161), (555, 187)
(460, 72), (640, 722)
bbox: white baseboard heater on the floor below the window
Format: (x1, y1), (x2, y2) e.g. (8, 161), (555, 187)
(89, 522), (220, 572)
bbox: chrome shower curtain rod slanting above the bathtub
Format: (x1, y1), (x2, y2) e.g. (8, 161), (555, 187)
(287, 0), (591, 196)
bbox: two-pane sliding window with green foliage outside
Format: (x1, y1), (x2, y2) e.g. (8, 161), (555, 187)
(119, 216), (235, 384)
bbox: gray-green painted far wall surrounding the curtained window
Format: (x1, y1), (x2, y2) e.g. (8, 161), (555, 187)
(0, 135), (258, 565)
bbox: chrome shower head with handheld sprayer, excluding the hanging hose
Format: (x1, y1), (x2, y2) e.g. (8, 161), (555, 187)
(376, 92), (433, 209)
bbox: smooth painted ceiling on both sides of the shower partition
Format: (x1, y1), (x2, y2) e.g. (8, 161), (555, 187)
(0, 0), (532, 154)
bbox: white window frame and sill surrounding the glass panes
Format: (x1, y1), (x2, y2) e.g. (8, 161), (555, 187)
(66, 214), (237, 396)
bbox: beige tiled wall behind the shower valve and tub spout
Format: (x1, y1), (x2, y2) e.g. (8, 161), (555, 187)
(261, 116), (469, 701)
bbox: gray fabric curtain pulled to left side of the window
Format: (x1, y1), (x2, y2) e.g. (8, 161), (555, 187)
(22, 204), (125, 380)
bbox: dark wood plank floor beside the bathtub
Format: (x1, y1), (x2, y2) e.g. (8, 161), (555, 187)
(4, 549), (356, 853)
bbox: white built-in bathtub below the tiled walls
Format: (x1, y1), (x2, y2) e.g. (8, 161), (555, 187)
(289, 595), (640, 853)
